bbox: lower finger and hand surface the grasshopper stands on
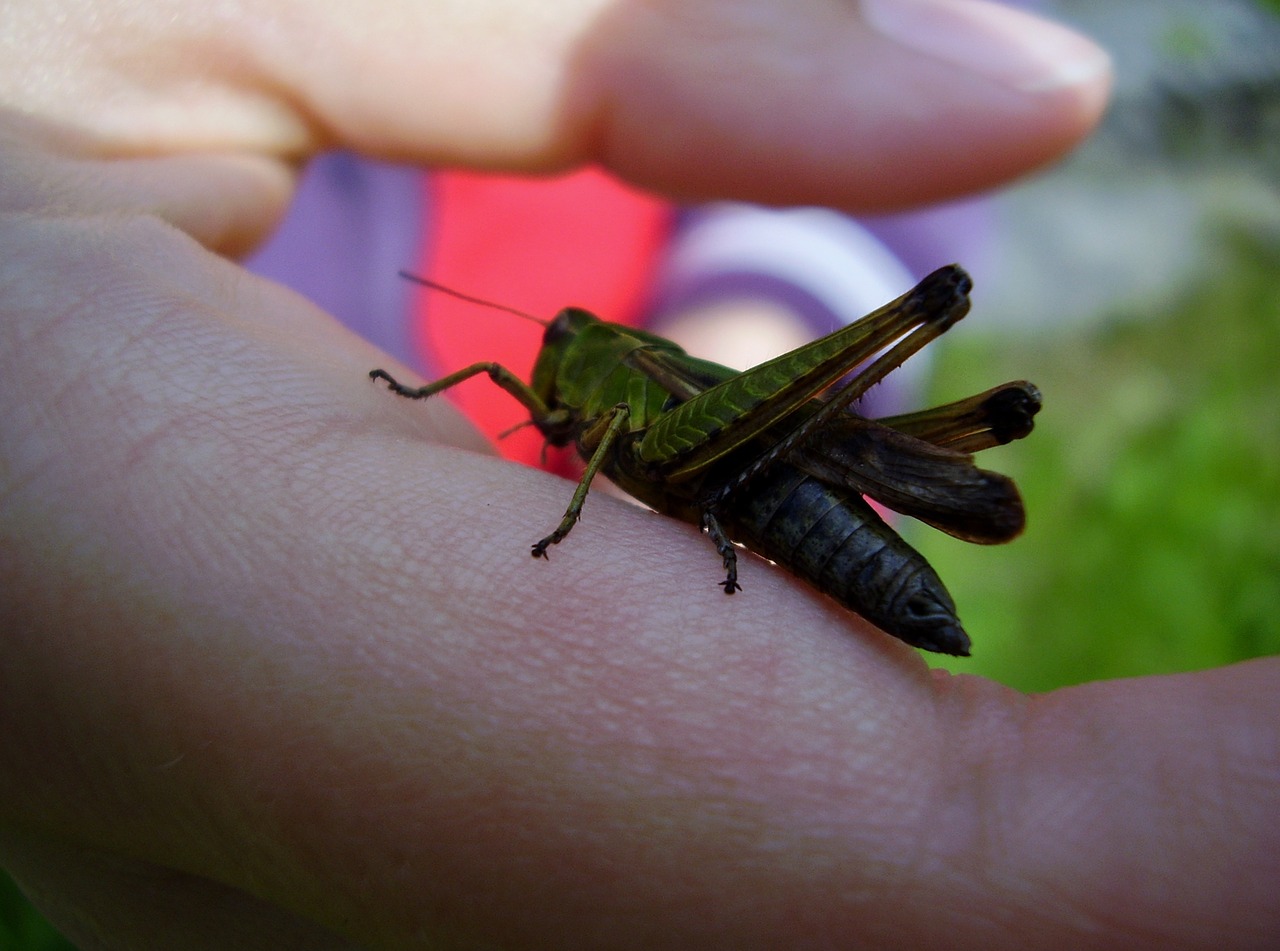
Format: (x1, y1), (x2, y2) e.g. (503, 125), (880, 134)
(0, 209), (1280, 947)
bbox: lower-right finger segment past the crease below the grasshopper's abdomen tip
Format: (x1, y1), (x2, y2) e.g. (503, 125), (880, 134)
(934, 658), (1280, 948)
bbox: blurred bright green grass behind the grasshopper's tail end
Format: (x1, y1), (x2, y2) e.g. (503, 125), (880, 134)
(908, 230), (1280, 690)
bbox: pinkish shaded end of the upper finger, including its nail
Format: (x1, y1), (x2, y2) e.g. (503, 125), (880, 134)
(585, 0), (1110, 211)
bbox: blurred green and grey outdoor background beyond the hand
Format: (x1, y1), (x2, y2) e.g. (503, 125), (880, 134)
(0, 0), (1280, 951)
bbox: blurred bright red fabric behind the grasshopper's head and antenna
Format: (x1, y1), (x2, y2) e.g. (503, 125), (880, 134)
(413, 169), (672, 465)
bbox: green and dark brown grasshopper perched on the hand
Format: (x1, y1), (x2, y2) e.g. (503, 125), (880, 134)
(369, 265), (1041, 655)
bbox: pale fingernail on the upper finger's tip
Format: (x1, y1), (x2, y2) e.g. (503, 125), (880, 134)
(861, 0), (1111, 93)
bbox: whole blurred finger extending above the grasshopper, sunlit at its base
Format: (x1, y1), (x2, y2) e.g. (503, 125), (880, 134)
(9, 0), (1108, 209)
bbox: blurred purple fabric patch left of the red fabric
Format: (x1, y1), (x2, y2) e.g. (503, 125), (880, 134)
(246, 152), (426, 366)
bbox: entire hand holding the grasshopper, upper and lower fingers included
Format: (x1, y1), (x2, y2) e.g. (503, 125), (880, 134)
(0, 0), (1280, 948)
